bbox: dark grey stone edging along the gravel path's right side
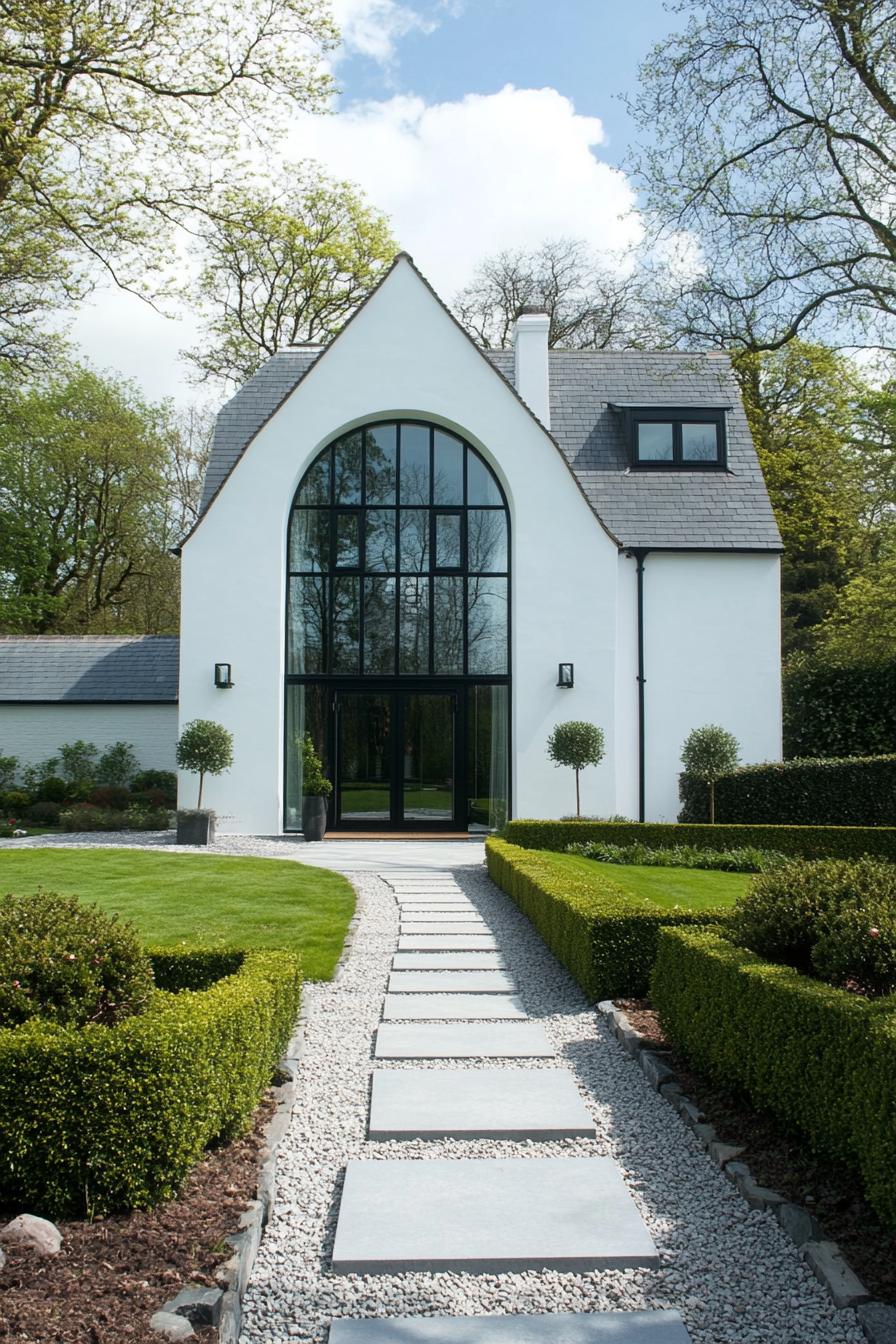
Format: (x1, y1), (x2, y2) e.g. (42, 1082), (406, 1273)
(598, 999), (896, 1344)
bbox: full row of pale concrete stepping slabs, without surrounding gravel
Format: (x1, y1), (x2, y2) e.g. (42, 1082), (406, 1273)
(329, 872), (689, 1344)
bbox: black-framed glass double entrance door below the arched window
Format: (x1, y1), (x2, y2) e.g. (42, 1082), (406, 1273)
(334, 689), (466, 831)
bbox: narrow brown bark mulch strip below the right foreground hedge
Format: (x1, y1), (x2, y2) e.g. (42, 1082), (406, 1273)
(615, 999), (896, 1304)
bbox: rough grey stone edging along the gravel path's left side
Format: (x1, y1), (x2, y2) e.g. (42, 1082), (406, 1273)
(150, 892), (361, 1344)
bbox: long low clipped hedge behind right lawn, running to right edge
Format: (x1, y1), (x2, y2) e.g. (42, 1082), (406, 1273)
(501, 821), (896, 862)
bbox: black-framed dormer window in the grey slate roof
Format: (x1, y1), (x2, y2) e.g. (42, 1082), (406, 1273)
(615, 406), (727, 472)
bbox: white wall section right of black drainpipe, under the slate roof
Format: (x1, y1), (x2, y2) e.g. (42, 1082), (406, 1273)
(642, 551), (780, 821)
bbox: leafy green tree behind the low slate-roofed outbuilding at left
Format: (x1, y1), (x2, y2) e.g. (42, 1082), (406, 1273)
(0, 367), (197, 634)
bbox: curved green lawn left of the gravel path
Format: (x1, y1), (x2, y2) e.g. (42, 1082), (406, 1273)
(0, 849), (355, 980)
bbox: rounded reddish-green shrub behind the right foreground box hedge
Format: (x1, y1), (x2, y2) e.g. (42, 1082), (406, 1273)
(731, 859), (896, 995)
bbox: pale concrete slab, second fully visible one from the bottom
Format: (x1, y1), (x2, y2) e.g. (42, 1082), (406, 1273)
(367, 1068), (595, 1141)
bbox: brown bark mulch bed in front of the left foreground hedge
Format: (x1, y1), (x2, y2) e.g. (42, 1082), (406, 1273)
(0, 1098), (274, 1344)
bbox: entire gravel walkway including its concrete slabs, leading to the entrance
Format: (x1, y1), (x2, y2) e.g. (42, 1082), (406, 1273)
(235, 855), (864, 1344)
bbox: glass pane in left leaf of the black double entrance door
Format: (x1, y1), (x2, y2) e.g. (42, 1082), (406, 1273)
(337, 692), (392, 823)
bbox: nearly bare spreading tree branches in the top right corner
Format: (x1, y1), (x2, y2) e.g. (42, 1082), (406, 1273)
(630, 0), (896, 348)
